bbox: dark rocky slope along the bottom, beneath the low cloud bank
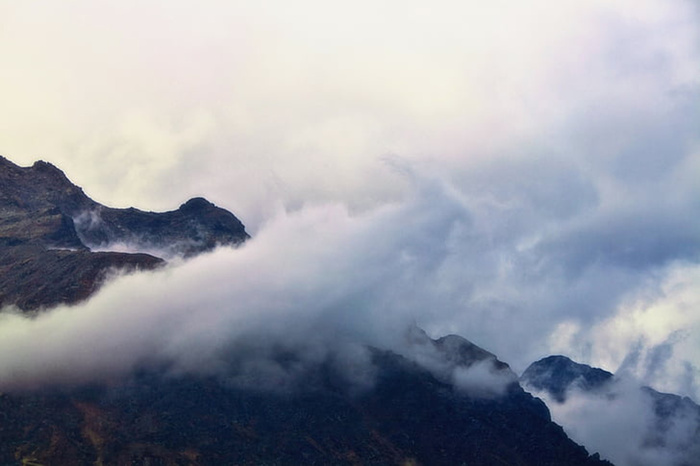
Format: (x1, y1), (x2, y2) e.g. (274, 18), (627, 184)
(0, 338), (608, 466)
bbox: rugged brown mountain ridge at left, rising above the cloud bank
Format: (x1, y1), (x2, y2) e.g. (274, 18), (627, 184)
(0, 156), (248, 311)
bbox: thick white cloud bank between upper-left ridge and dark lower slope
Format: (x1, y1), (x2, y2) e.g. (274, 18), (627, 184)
(0, 177), (468, 392)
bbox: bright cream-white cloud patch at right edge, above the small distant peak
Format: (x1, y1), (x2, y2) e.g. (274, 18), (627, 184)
(551, 263), (700, 400)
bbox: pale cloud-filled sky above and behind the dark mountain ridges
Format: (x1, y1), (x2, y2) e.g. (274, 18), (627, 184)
(0, 0), (700, 456)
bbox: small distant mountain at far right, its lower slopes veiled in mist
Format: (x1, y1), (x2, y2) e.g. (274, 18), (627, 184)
(520, 356), (700, 466)
